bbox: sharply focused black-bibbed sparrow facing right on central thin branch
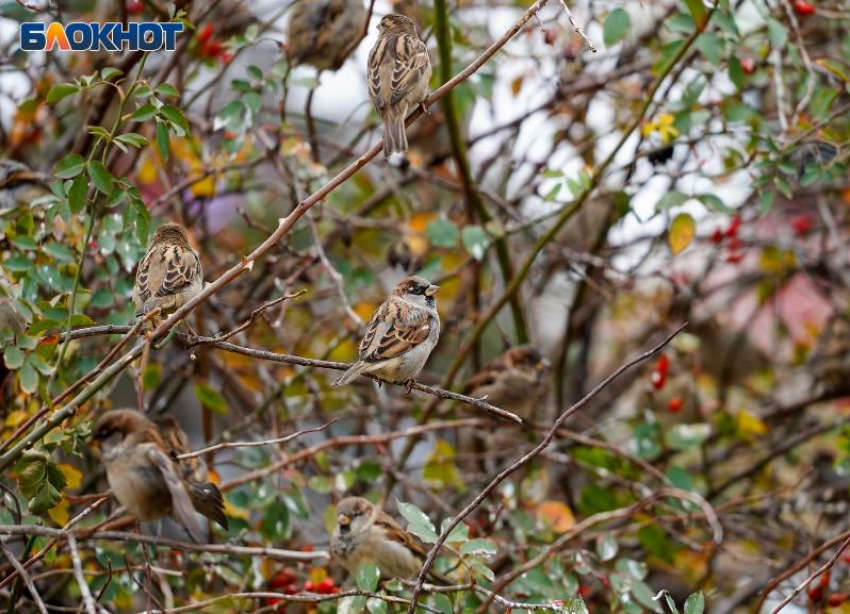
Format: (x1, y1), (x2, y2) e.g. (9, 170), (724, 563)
(333, 277), (440, 386)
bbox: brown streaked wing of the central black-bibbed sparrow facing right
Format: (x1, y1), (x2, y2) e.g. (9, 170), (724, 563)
(360, 298), (432, 363)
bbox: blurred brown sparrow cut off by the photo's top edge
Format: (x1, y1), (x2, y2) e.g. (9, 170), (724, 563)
(289, 0), (366, 70)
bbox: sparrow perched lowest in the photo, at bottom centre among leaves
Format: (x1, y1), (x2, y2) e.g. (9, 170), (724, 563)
(331, 497), (451, 584)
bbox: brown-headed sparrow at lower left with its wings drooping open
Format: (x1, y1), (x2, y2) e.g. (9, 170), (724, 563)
(93, 409), (227, 539)
